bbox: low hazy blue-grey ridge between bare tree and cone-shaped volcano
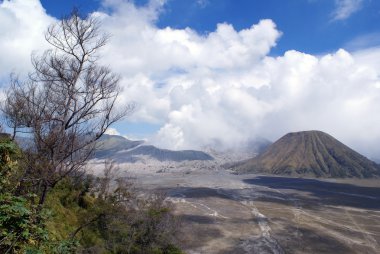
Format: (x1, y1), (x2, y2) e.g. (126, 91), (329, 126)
(95, 135), (213, 163)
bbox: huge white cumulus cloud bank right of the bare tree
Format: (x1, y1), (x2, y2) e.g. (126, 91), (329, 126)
(0, 0), (380, 157)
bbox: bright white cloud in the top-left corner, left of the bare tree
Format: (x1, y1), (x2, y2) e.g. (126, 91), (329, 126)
(0, 0), (55, 80)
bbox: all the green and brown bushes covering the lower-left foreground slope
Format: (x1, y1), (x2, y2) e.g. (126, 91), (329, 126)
(0, 136), (181, 254)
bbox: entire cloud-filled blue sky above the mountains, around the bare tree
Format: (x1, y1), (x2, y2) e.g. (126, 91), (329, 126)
(0, 0), (380, 158)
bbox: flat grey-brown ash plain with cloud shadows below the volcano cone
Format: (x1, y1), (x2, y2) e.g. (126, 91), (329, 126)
(87, 158), (380, 254)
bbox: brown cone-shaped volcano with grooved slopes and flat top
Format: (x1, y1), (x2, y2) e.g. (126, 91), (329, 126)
(234, 131), (380, 178)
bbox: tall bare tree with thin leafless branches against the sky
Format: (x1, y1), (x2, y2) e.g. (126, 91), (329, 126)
(2, 11), (133, 204)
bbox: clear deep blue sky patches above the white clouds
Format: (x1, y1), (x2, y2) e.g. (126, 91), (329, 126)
(41, 0), (380, 55)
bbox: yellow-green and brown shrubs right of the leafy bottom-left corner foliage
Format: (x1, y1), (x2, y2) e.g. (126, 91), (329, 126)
(43, 177), (182, 254)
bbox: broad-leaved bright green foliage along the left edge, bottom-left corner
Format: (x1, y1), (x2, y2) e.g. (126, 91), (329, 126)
(0, 139), (48, 253)
